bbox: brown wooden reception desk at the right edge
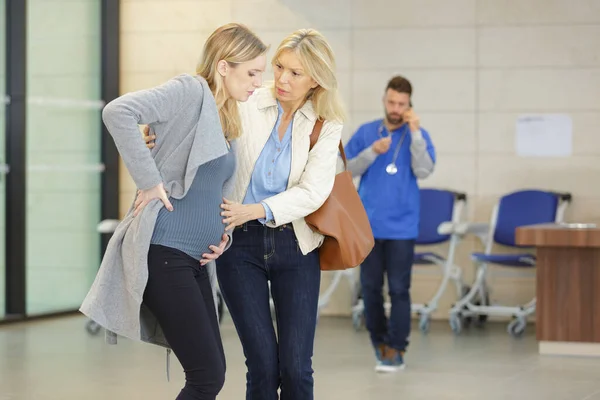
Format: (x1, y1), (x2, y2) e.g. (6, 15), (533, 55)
(516, 224), (600, 357)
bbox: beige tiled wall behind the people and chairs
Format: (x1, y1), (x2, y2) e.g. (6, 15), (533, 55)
(121, 0), (600, 317)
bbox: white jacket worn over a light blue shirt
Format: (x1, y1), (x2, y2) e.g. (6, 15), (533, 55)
(231, 88), (342, 254)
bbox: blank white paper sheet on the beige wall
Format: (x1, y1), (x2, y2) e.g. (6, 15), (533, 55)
(515, 114), (573, 157)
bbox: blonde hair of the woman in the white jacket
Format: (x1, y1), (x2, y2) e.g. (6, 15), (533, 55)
(273, 29), (346, 123)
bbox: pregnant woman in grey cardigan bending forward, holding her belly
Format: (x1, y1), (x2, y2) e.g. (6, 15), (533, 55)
(81, 24), (267, 400)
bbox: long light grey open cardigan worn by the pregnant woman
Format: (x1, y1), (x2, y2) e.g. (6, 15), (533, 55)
(80, 75), (235, 348)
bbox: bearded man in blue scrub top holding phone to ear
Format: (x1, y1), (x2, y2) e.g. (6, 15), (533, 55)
(345, 76), (435, 372)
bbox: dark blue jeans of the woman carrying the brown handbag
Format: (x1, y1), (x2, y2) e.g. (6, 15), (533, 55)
(217, 221), (321, 400)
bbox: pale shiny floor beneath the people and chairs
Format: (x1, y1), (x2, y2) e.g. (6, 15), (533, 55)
(0, 317), (600, 400)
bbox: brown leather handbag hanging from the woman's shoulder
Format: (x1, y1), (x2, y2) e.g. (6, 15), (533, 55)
(304, 120), (375, 271)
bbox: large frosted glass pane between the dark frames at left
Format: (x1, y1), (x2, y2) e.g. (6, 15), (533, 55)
(26, 0), (102, 315)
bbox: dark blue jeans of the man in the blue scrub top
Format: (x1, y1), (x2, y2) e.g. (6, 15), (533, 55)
(360, 239), (415, 351)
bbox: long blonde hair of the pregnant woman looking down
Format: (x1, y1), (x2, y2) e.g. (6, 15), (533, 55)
(196, 23), (268, 140)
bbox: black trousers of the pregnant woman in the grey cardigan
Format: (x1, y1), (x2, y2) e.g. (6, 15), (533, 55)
(144, 245), (225, 400)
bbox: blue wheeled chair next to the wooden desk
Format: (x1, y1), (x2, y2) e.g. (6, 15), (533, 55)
(449, 190), (571, 337)
